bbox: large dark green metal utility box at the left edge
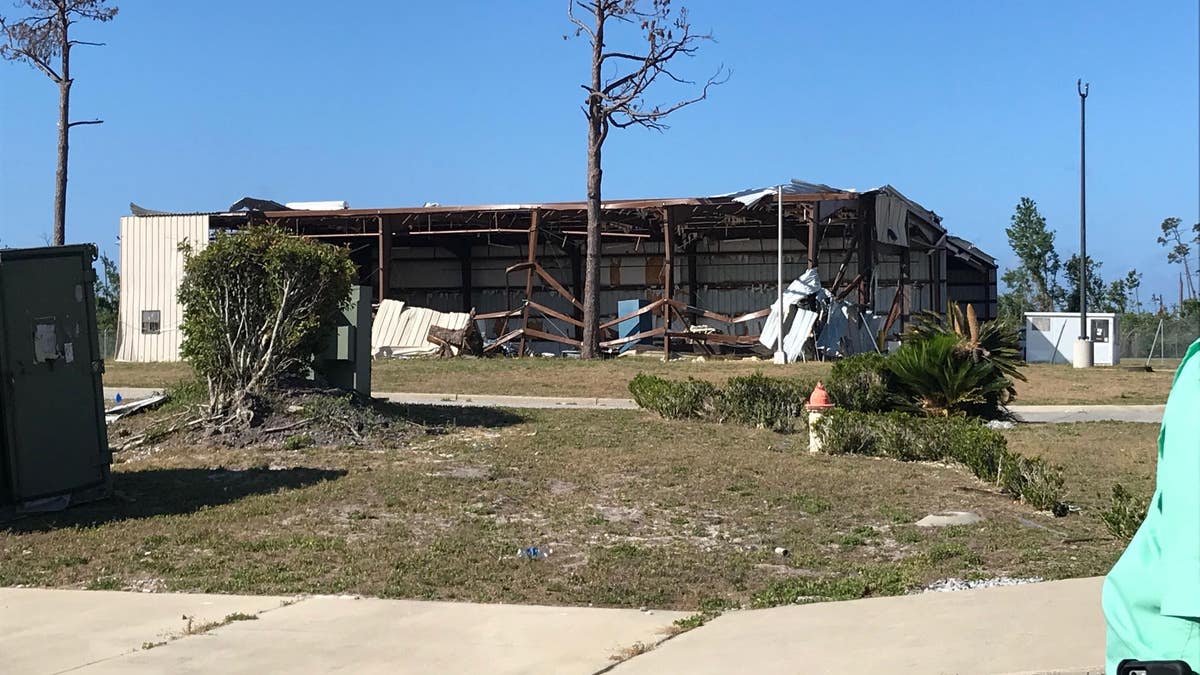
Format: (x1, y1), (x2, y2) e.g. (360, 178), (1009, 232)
(0, 244), (112, 511)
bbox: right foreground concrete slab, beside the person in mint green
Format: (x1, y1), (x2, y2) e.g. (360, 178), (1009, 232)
(613, 578), (1104, 675)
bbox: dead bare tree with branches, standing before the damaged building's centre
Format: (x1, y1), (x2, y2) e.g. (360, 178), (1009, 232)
(566, 0), (728, 358)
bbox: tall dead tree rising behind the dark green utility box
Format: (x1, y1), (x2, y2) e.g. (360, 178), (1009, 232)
(0, 0), (118, 246)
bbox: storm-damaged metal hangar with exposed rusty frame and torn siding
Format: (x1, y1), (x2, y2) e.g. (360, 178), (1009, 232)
(118, 180), (997, 360)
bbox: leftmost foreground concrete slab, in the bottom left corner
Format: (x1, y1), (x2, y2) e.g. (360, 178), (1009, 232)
(0, 589), (287, 674)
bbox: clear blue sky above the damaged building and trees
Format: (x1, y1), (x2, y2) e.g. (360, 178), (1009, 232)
(0, 0), (1200, 301)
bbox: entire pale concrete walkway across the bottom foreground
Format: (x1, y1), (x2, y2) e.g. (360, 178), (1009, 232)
(0, 579), (1104, 675)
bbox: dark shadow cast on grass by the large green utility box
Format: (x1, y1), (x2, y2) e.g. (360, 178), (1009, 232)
(8, 467), (346, 534)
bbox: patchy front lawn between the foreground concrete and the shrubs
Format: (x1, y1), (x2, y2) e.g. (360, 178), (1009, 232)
(0, 408), (1157, 610)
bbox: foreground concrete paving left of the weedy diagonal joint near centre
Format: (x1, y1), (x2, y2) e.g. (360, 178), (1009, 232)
(0, 589), (686, 675)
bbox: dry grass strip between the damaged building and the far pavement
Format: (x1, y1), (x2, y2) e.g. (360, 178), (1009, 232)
(104, 357), (1174, 405)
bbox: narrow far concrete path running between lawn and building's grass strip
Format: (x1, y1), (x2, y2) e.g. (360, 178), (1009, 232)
(104, 387), (1165, 424)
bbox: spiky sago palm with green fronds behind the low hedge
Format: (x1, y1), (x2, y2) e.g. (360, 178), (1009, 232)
(888, 333), (1014, 419)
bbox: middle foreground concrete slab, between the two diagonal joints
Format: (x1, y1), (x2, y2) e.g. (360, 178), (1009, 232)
(80, 597), (685, 675)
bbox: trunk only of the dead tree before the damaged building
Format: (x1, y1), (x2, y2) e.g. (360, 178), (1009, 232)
(580, 2), (608, 359)
